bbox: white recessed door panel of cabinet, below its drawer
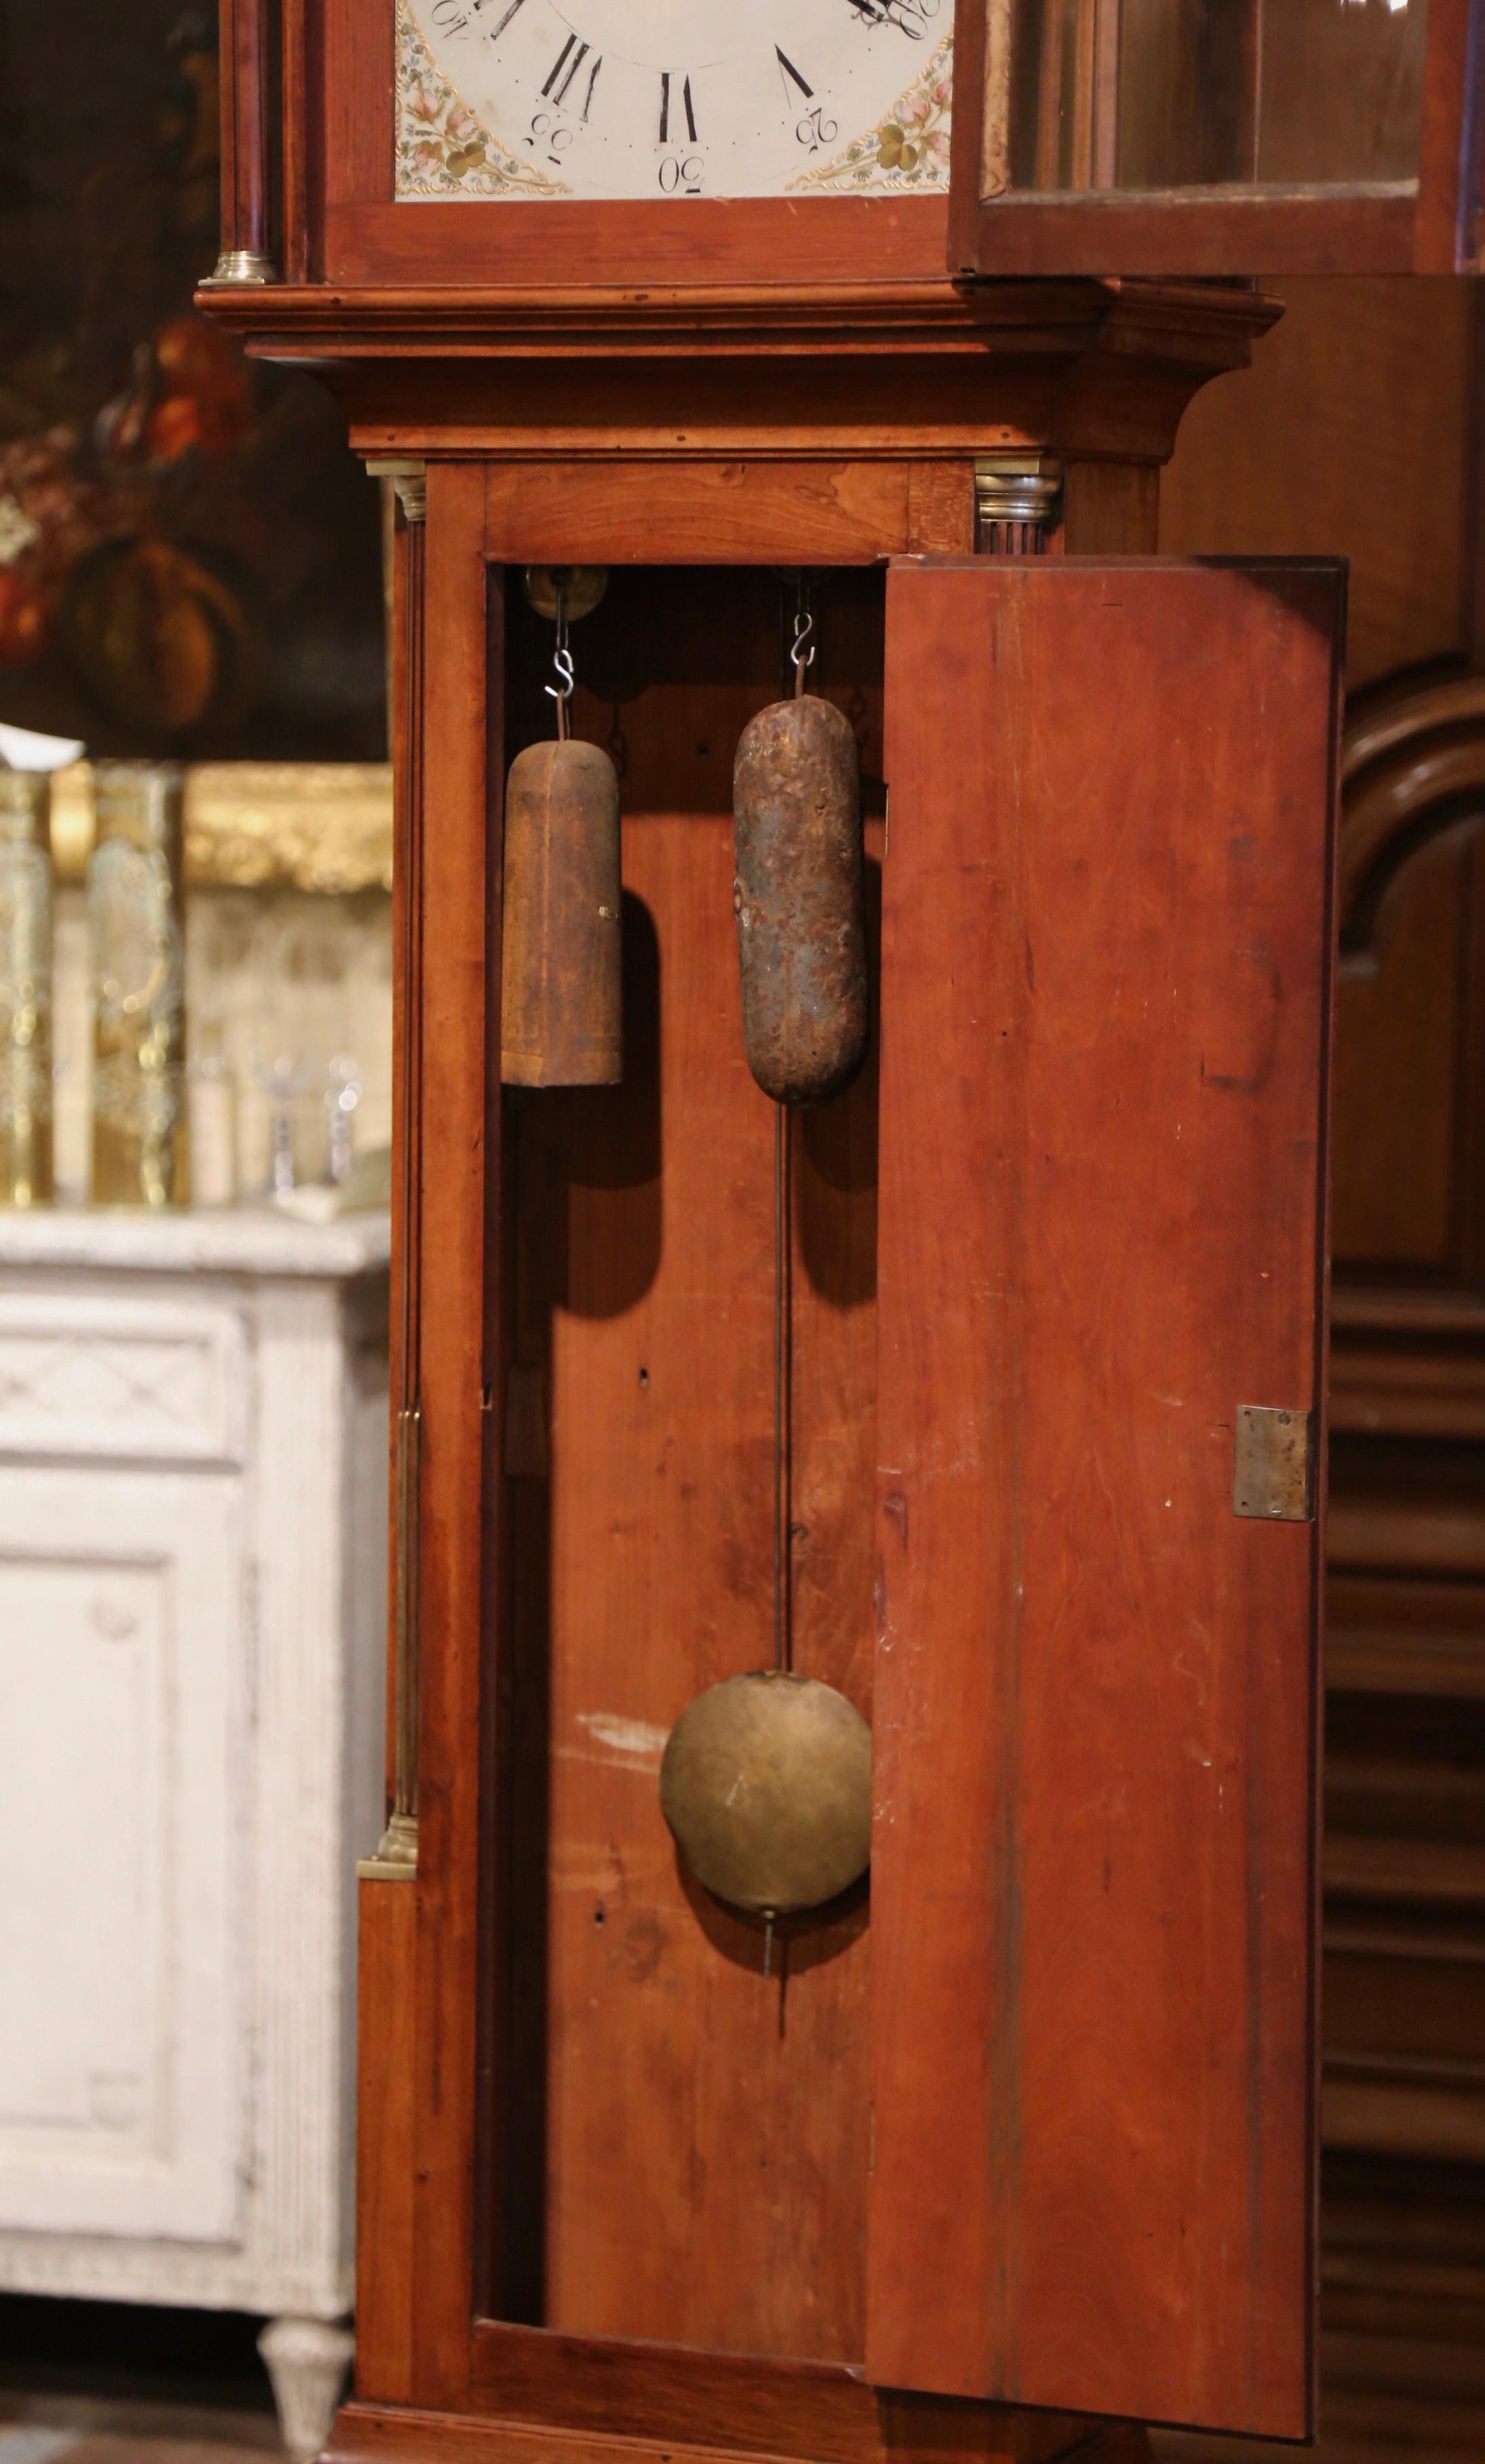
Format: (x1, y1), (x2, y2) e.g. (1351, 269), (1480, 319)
(0, 1468), (246, 2242)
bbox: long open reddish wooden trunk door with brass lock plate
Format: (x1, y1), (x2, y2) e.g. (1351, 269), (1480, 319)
(867, 560), (1345, 2437)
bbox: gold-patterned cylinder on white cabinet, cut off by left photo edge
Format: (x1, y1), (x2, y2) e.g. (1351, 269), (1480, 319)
(0, 768), (52, 1207)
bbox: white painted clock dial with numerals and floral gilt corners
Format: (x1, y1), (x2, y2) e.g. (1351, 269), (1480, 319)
(396, 0), (953, 199)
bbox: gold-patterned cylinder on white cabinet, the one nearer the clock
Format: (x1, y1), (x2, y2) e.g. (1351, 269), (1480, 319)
(89, 762), (190, 1207)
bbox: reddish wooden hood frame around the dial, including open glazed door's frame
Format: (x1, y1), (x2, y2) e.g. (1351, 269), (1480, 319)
(206, 0), (1485, 295)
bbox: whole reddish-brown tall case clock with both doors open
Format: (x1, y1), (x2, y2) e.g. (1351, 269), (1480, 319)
(202, 0), (1482, 2464)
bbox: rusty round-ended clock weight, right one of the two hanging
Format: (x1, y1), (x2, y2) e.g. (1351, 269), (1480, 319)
(731, 695), (867, 1104)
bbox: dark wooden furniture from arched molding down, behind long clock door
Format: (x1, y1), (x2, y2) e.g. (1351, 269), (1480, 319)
(1325, 668), (1485, 2444)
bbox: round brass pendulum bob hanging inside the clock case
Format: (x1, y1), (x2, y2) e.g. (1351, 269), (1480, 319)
(660, 1668), (872, 1917)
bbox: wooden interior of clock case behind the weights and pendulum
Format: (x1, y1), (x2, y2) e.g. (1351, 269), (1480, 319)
(480, 567), (884, 2363)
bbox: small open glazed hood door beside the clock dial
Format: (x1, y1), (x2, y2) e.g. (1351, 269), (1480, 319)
(950, 0), (1485, 276)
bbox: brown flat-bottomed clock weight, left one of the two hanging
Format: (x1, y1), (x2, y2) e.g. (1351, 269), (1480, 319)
(500, 737), (623, 1087)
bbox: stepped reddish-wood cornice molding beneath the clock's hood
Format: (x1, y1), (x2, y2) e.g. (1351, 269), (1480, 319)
(199, 279), (1278, 466)
